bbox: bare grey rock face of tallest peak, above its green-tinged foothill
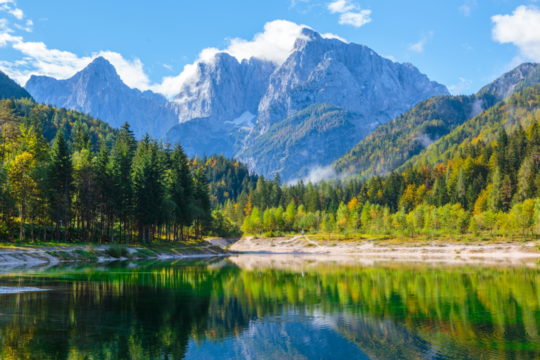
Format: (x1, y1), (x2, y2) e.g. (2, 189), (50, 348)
(251, 29), (449, 136)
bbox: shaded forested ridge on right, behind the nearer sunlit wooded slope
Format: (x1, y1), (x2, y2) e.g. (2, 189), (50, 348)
(333, 63), (540, 179)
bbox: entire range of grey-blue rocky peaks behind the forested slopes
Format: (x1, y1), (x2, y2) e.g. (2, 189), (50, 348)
(25, 29), (449, 179)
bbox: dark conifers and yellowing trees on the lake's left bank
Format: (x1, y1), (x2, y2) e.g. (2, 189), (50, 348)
(0, 100), (221, 243)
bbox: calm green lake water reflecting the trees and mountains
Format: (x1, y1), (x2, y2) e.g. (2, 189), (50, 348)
(0, 255), (540, 359)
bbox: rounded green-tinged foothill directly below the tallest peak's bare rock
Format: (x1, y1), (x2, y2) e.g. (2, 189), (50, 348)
(242, 104), (372, 179)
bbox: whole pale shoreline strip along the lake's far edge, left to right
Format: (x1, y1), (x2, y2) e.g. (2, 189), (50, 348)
(4, 235), (540, 268)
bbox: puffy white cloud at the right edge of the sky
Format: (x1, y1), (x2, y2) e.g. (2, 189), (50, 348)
(491, 5), (540, 61)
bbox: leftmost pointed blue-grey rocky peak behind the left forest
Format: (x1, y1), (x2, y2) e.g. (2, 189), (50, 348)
(25, 57), (178, 137)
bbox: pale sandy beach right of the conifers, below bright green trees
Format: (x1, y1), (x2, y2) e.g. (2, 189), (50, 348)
(230, 236), (540, 260)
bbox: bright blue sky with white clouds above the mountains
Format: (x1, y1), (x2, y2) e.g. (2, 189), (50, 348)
(0, 0), (540, 97)
